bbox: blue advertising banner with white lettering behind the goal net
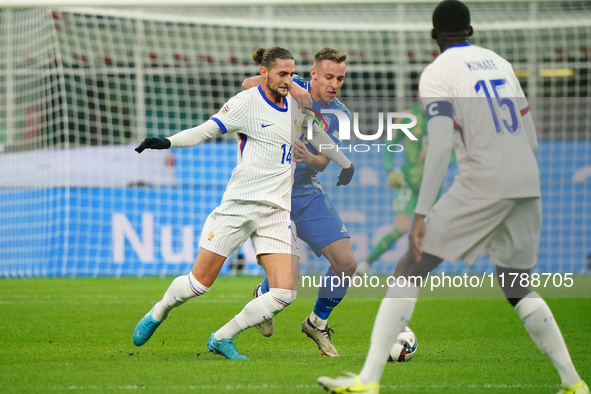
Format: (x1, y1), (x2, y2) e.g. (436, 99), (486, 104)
(0, 141), (591, 277)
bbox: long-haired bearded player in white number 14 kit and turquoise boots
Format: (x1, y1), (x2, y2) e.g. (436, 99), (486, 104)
(133, 47), (353, 360)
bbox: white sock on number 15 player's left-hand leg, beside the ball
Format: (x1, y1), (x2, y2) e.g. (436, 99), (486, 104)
(359, 285), (419, 384)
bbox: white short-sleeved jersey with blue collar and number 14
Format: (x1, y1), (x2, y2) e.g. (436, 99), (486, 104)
(211, 85), (295, 210)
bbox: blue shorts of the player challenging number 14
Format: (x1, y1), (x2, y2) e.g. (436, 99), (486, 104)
(291, 190), (350, 256)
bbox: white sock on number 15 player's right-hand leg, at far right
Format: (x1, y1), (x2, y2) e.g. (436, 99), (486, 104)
(515, 292), (581, 387)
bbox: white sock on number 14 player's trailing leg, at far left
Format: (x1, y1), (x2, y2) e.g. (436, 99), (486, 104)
(152, 272), (209, 321)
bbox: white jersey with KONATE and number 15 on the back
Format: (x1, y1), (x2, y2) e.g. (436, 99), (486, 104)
(419, 43), (540, 199)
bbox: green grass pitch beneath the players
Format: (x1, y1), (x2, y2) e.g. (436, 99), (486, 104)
(0, 276), (591, 394)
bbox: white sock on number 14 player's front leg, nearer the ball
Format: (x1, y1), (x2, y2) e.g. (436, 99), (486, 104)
(214, 288), (296, 340)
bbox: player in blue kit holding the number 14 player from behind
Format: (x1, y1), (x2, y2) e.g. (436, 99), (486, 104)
(242, 48), (357, 357)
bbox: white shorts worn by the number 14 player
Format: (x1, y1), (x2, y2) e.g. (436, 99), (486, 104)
(199, 200), (296, 257)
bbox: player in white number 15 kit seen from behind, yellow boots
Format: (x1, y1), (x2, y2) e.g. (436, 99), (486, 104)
(318, 0), (589, 394)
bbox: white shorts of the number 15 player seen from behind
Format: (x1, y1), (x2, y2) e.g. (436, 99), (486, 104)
(423, 192), (542, 269)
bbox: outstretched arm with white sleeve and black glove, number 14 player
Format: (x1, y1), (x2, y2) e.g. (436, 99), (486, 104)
(135, 119), (221, 153)
